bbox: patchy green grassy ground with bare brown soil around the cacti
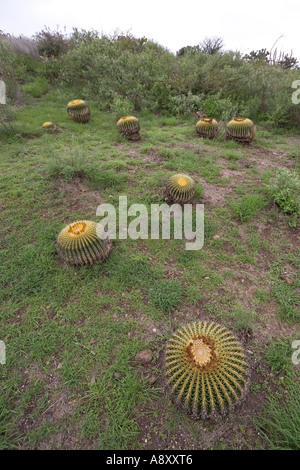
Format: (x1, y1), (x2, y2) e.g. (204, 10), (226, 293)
(0, 90), (300, 450)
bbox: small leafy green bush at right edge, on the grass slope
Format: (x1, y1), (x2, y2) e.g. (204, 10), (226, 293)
(267, 168), (300, 227)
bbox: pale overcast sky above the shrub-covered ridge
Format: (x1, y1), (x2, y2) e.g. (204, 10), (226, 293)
(0, 0), (300, 61)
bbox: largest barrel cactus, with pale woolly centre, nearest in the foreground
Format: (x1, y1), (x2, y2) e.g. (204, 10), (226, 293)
(165, 321), (249, 419)
